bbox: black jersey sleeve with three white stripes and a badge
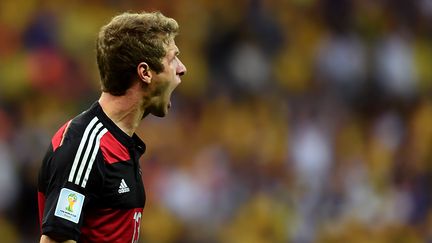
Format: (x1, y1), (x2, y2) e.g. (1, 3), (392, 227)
(38, 126), (104, 241)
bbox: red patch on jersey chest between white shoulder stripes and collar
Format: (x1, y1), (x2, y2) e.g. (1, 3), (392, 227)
(100, 132), (130, 164)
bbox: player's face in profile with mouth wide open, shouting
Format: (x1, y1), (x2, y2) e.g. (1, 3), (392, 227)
(151, 40), (186, 117)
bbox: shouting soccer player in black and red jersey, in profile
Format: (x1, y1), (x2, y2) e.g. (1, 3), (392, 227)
(38, 12), (186, 242)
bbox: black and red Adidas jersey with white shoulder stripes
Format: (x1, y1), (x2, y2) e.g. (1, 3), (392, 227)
(38, 102), (145, 242)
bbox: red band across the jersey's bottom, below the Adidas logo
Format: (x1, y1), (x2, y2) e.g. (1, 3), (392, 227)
(79, 208), (143, 243)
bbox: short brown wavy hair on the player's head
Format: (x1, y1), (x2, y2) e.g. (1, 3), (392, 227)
(96, 12), (179, 96)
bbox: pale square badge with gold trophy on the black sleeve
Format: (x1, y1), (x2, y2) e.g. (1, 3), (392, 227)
(54, 188), (85, 224)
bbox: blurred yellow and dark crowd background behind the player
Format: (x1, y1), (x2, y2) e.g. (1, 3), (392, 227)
(0, 0), (432, 243)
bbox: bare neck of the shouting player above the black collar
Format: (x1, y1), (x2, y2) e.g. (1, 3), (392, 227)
(99, 84), (144, 136)
